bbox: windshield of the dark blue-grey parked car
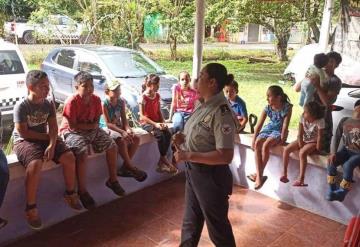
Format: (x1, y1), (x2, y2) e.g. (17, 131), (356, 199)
(99, 51), (164, 77)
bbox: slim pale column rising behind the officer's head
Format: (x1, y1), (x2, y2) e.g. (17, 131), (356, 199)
(192, 0), (205, 86)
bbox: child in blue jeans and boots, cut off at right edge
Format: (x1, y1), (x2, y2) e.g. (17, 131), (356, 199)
(326, 100), (360, 201)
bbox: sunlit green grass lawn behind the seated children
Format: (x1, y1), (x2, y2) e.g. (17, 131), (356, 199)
(23, 45), (302, 129)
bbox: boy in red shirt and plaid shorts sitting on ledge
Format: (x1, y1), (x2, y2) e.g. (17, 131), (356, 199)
(60, 71), (125, 209)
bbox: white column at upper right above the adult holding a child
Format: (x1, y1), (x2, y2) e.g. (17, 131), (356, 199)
(319, 0), (334, 52)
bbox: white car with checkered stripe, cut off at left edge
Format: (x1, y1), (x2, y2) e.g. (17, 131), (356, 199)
(0, 39), (28, 122)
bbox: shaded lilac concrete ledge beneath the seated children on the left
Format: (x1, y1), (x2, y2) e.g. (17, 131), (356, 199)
(0, 129), (183, 246)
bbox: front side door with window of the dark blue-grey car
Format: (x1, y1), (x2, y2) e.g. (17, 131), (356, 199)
(76, 51), (106, 98)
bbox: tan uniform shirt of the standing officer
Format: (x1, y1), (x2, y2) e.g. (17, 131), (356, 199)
(184, 92), (235, 152)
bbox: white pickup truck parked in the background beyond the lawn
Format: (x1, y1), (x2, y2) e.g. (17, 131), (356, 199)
(4, 15), (83, 44)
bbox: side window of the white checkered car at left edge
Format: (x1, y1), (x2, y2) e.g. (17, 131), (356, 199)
(0, 50), (25, 75)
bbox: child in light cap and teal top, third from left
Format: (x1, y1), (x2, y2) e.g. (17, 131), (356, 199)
(100, 80), (147, 182)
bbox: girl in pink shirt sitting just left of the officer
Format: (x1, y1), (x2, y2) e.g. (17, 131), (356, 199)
(167, 71), (198, 133)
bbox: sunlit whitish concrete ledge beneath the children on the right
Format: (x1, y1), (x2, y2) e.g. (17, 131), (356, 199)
(230, 135), (360, 224)
